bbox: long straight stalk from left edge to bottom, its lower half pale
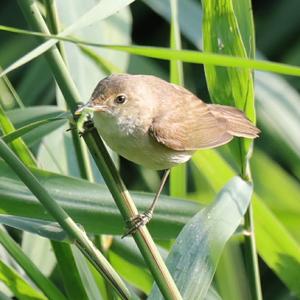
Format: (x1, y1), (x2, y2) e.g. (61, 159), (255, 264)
(0, 138), (130, 299)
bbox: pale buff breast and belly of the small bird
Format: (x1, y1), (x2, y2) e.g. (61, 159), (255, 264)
(94, 113), (192, 170)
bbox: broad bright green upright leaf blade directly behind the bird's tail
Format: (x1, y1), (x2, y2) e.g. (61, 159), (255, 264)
(203, 0), (255, 176)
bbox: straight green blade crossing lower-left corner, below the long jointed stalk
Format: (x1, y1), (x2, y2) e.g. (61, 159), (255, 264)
(0, 229), (66, 300)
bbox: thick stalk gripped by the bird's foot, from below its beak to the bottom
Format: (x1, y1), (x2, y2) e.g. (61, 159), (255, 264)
(83, 122), (182, 299)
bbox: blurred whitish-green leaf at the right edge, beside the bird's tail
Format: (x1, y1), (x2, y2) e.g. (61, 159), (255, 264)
(255, 72), (300, 169)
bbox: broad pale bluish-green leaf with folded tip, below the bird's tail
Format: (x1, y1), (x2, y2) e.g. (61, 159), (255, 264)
(149, 177), (252, 300)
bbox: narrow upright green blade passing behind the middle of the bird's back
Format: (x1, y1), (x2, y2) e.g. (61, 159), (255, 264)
(169, 0), (186, 197)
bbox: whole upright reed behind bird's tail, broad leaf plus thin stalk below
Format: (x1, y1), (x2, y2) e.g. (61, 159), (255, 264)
(202, 0), (262, 300)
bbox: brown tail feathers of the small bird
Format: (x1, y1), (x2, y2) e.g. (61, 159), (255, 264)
(208, 104), (260, 139)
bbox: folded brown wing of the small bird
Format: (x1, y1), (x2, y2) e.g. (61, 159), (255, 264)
(149, 97), (233, 151)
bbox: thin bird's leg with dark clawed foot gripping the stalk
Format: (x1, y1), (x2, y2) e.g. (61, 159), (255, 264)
(122, 169), (170, 238)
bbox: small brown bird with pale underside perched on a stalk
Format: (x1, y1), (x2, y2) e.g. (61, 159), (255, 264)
(76, 74), (260, 233)
